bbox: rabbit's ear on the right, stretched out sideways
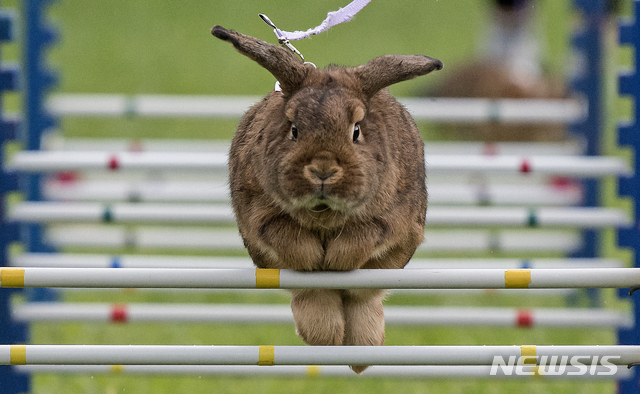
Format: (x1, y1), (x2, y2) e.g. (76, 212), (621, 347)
(355, 55), (442, 97)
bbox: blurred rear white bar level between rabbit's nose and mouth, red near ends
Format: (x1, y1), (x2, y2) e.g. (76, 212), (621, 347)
(42, 179), (583, 206)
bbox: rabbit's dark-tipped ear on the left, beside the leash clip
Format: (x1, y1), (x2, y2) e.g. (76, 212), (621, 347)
(211, 26), (312, 93)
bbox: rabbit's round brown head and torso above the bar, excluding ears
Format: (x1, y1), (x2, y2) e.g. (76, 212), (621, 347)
(229, 88), (427, 271)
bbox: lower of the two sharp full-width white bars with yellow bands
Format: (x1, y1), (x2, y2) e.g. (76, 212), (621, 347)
(0, 345), (640, 366)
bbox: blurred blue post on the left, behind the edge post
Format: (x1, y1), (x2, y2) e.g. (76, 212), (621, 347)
(20, 0), (57, 301)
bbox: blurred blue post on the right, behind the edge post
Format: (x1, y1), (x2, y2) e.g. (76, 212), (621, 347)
(571, 0), (607, 307)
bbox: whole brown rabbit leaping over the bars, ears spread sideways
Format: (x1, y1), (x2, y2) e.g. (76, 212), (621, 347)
(211, 26), (442, 373)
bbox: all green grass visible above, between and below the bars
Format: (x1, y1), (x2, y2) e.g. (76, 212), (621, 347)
(3, 0), (632, 394)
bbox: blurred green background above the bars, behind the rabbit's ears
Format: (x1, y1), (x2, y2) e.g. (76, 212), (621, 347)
(46, 0), (571, 142)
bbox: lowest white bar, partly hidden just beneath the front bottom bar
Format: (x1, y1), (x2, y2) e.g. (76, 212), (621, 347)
(14, 365), (633, 379)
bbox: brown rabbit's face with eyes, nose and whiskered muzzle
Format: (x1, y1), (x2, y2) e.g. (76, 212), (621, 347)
(271, 86), (385, 227)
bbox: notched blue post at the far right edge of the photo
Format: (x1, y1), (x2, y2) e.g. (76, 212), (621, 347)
(618, 0), (640, 394)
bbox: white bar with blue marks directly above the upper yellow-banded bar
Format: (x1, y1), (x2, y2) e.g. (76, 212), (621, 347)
(9, 253), (625, 269)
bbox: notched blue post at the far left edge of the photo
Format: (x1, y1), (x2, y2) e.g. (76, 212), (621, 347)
(0, 3), (30, 394)
